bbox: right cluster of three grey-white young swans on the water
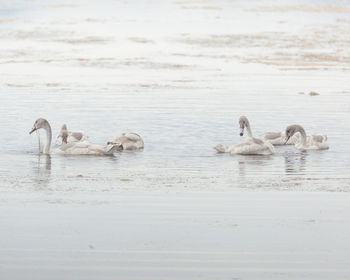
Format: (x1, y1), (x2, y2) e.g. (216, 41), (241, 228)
(214, 116), (328, 155)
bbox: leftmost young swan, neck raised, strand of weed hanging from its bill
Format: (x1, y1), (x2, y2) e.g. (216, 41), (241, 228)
(29, 118), (121, 156)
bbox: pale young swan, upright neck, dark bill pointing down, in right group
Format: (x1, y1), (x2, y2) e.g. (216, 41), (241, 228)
(214, 116), (275, 155)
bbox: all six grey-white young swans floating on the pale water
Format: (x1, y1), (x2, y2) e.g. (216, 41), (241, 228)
(29, 116), (328, 155)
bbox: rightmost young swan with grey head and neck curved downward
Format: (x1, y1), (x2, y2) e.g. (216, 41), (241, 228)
(285, 124), (329, 151)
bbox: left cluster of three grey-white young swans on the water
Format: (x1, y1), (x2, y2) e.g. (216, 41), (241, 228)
(29, 118), (144, 155)
